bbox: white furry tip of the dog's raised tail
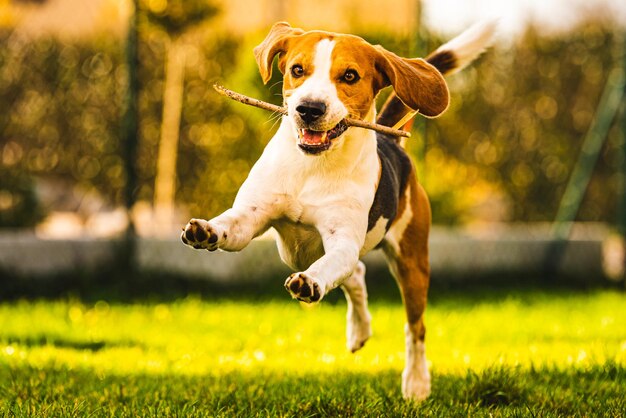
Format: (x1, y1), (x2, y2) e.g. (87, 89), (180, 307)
(435, 20), (497, 74)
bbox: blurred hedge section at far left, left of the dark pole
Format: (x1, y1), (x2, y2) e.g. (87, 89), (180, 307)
(0, 33), (125, 226)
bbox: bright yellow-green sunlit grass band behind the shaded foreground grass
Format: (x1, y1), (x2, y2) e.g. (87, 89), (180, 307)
(0, 292), (626, 375)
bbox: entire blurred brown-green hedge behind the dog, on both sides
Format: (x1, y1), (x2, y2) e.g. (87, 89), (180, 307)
(0, 16), (620, 226)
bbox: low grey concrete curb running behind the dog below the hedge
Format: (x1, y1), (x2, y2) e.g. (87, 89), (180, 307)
(0, 224), (610, 282)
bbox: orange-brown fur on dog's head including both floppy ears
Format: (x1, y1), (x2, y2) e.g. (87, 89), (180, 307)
(254, 22), (449, 118)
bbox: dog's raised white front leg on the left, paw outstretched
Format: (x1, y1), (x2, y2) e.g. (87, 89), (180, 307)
(181, 205), (269, 251)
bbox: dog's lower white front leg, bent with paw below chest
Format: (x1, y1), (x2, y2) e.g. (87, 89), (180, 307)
(285, 220), (365, 303)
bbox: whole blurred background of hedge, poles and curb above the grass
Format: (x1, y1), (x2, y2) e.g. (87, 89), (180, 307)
(0, 0), (626, 293)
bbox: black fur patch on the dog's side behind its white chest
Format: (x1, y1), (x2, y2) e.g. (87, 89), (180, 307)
(367, 134), (412, 235)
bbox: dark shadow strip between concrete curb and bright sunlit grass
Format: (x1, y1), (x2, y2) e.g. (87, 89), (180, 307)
(0, 262), (623, 304)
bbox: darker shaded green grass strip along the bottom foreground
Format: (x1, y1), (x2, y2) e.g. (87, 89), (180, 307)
(0, 363), (626, 417)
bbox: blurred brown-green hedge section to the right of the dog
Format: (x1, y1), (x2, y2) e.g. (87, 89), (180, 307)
(426, 22), (624, 222)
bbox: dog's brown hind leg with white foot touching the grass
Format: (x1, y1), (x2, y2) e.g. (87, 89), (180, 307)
(383, 175), (430, 400)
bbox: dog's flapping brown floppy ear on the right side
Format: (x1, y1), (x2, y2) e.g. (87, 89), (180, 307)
(376, 46), (450, 118)
